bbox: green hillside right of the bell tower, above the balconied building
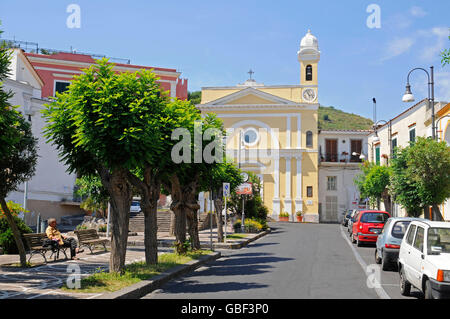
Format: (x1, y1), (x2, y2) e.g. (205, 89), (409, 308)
(319, 106), (373, 130)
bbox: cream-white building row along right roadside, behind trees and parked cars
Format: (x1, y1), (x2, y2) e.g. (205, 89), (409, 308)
(369, 99), (450, 220)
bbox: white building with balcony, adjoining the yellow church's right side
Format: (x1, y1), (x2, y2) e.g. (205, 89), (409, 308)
(319, 130), (370, 222)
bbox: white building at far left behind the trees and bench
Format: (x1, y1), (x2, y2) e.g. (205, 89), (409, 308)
(3, 49), (83, 225)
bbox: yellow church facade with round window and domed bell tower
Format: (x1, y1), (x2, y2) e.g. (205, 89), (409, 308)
(197, 31), (320, 222)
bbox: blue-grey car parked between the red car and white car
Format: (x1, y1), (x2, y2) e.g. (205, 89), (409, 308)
(375, 217), (421, 270)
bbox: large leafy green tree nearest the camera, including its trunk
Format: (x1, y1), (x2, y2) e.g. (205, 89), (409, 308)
(43, 59), (165, 272)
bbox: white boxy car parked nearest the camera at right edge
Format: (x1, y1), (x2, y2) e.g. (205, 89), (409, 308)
(398, 220), (450, 299)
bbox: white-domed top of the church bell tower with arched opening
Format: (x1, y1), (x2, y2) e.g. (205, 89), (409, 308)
(297, 30), (320, 85)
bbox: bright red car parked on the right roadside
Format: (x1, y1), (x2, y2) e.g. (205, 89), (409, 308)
(351, 210), (391, 247)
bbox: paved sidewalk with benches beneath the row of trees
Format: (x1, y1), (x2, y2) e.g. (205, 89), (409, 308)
(0, 225), (267, 299)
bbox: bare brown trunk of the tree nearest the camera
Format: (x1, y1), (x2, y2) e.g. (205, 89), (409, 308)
(100, 169), (133, 273)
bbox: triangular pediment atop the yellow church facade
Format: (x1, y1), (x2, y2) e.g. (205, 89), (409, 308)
(208, 88), (296, 106)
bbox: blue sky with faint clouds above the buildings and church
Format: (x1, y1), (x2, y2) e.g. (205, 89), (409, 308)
(0, 0), (450, 120)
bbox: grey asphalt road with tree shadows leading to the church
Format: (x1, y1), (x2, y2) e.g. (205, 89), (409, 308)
(144, 223), (382, 299)
